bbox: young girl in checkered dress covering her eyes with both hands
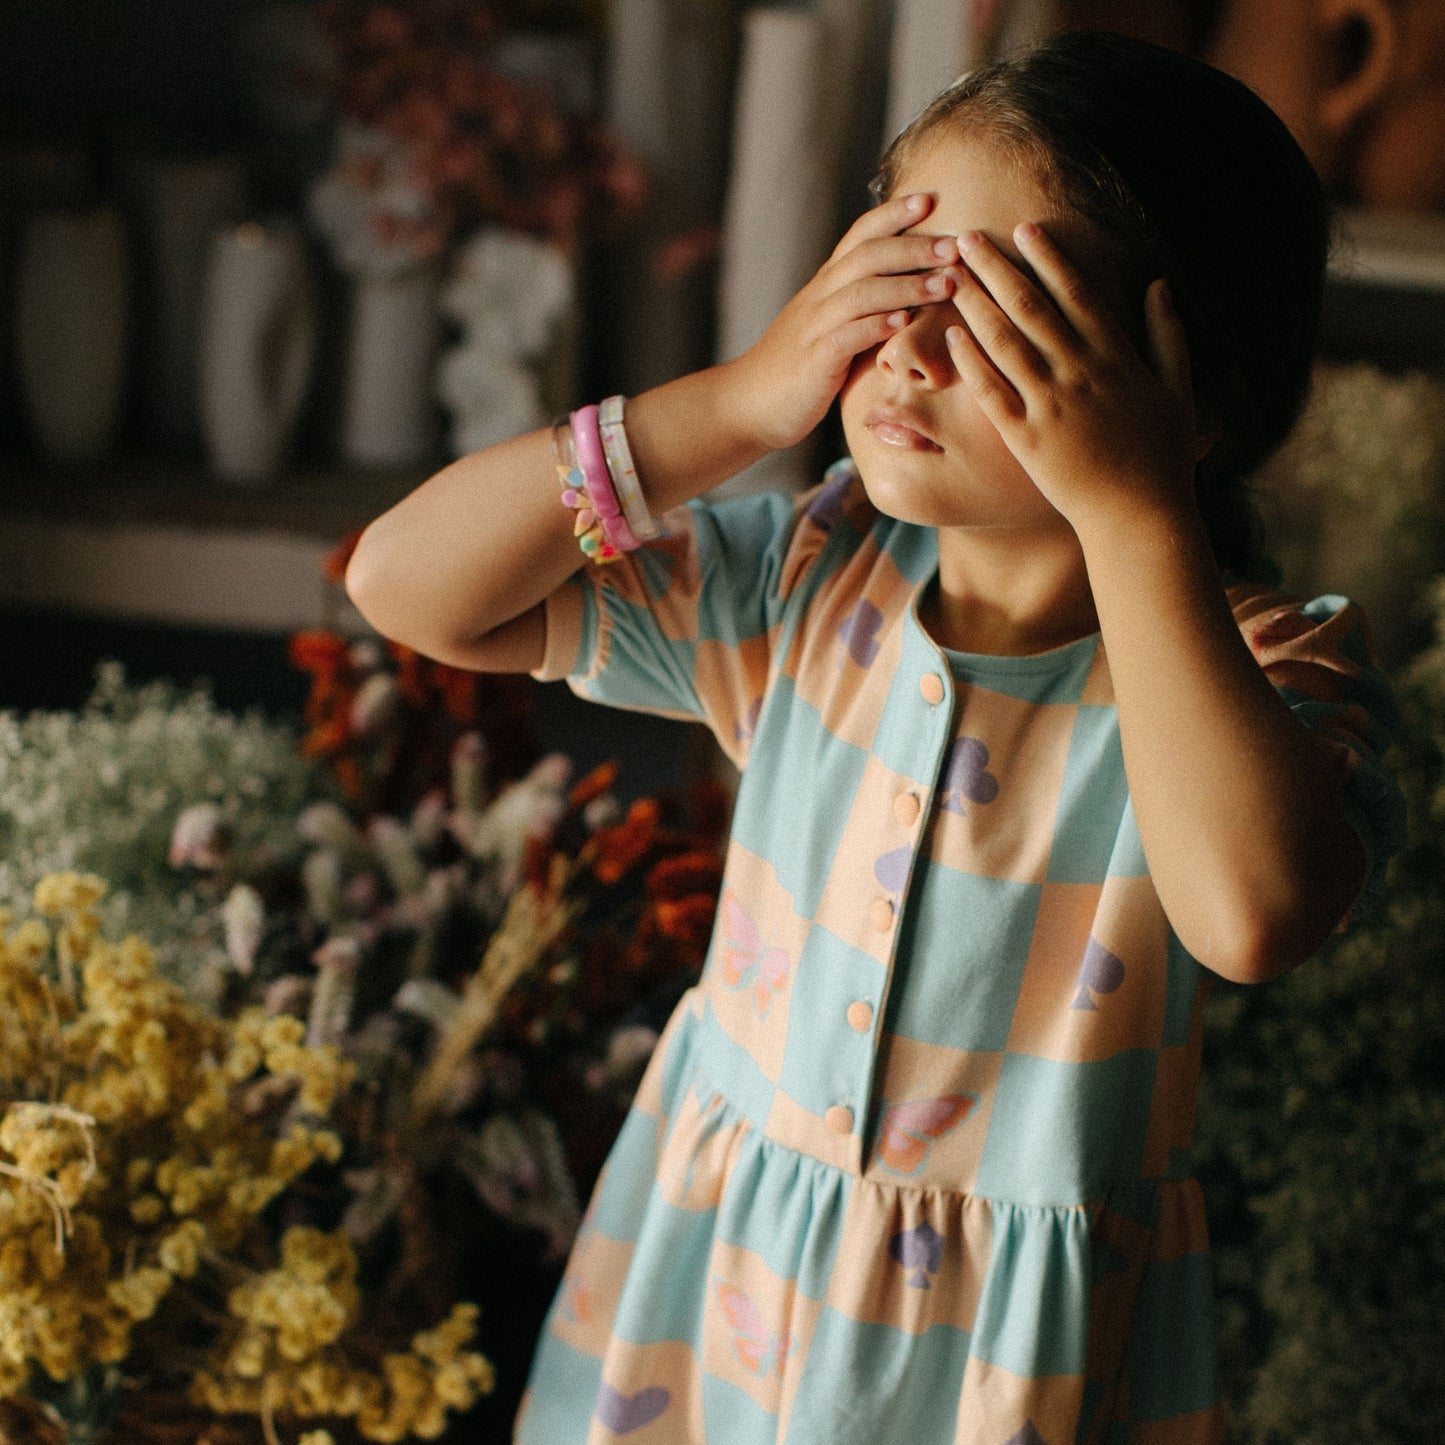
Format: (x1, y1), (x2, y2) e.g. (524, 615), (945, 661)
(348, 25), (1397, 1445)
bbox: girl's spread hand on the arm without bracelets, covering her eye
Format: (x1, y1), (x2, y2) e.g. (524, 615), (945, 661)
(945, 225), (1202, 529)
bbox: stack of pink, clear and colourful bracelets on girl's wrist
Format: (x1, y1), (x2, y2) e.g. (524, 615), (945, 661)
(552, 396), (659, 562)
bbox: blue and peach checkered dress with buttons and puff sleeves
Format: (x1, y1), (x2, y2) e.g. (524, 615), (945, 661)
(516, 464), (1399, 1445)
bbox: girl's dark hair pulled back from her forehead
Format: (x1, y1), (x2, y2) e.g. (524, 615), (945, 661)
(874, 32), (1329, 574)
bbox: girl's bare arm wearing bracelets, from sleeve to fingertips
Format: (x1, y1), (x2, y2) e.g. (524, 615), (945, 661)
(347, 197), (957, 672)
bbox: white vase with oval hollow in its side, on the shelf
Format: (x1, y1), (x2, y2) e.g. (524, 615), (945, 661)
(199, 216), (316, 486)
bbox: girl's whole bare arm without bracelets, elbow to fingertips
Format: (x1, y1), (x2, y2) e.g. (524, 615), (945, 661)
(948, 227), (1366, 983)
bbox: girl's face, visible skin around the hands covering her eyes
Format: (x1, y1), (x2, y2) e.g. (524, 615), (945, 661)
(840, 129), (1123, 530)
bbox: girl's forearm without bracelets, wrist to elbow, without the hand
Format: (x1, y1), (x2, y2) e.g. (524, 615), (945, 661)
(1081, 497), (1364, 983)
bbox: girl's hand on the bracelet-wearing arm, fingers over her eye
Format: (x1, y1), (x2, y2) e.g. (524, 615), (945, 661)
(730, 195), (958, 449)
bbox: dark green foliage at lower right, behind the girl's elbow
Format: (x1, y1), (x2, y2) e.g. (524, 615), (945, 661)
(1198, 585), (1445, 1445)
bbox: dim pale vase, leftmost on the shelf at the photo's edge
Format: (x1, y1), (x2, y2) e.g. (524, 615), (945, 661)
(14, 208), (130, 465)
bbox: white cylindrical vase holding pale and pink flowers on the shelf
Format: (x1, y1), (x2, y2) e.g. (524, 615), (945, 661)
(341, 266), (441, 467)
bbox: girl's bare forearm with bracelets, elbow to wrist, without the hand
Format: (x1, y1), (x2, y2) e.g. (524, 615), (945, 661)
(347, 363), (766, 665)
